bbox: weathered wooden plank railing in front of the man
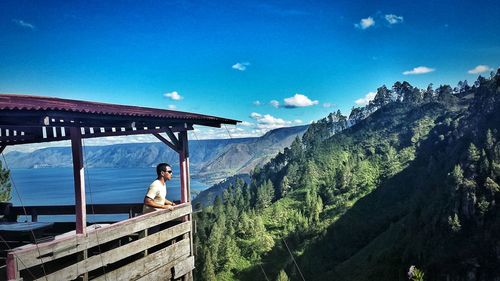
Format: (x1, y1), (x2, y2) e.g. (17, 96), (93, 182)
(5, 203), (194, 281)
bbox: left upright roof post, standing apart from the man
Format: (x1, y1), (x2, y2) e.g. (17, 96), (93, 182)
(70, 127), (87, 234)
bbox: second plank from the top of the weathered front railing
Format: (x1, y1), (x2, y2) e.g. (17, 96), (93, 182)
(37, 222), (191, 281)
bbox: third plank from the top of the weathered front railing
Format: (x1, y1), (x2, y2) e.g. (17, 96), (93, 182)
(92, 241), (189, 281)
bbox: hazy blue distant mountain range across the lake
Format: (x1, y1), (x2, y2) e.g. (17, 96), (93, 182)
(6, 125), (308, 184)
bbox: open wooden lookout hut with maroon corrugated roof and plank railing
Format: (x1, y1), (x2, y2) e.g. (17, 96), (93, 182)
(0, 94), (241, 281)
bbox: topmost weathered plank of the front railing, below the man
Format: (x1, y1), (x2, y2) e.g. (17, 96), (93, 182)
(12, 204), (191, 270)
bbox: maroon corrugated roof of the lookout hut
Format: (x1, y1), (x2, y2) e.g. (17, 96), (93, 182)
(0, 94), (240, 146)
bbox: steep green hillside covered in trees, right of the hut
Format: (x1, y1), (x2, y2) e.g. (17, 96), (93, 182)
(196, 69), (500, 280)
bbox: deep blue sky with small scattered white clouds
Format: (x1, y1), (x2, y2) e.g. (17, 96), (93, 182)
(0, 0), (500, 144)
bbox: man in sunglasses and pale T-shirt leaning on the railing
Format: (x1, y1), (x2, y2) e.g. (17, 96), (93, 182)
(142, 163), (175, 214)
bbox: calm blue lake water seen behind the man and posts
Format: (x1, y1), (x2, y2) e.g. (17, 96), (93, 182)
(11, 168), (208, 220)
